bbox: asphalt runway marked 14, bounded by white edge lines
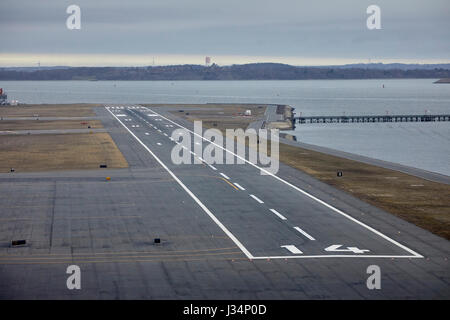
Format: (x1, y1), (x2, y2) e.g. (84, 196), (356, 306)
(107, 106), (423, 259)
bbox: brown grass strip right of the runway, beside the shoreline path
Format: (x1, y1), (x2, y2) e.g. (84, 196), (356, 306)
(280, 144), (450, 240)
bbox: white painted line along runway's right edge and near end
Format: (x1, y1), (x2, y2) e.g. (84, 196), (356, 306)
(145, 107), (423, 259)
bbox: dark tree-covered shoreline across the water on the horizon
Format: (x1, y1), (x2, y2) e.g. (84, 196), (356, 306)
(0, 63), (450, 80)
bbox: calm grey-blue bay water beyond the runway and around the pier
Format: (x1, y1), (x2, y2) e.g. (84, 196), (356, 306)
(0, 79), (450, 175)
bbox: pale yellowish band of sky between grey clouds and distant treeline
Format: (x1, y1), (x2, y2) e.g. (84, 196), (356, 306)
(0, 53), (450, 68)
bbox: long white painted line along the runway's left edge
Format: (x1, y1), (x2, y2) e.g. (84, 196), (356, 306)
(106, 108), (254, 259)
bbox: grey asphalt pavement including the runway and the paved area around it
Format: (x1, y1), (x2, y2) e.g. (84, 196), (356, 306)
(0, 105), (450, 299)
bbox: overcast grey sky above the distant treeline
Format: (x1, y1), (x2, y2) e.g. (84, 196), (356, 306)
(0, 0), (450, 66)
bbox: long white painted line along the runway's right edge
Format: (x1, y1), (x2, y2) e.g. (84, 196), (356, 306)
(140, 107), (423, 258)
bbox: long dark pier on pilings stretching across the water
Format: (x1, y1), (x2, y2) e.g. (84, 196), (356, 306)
(293, 114), (450, 124)
